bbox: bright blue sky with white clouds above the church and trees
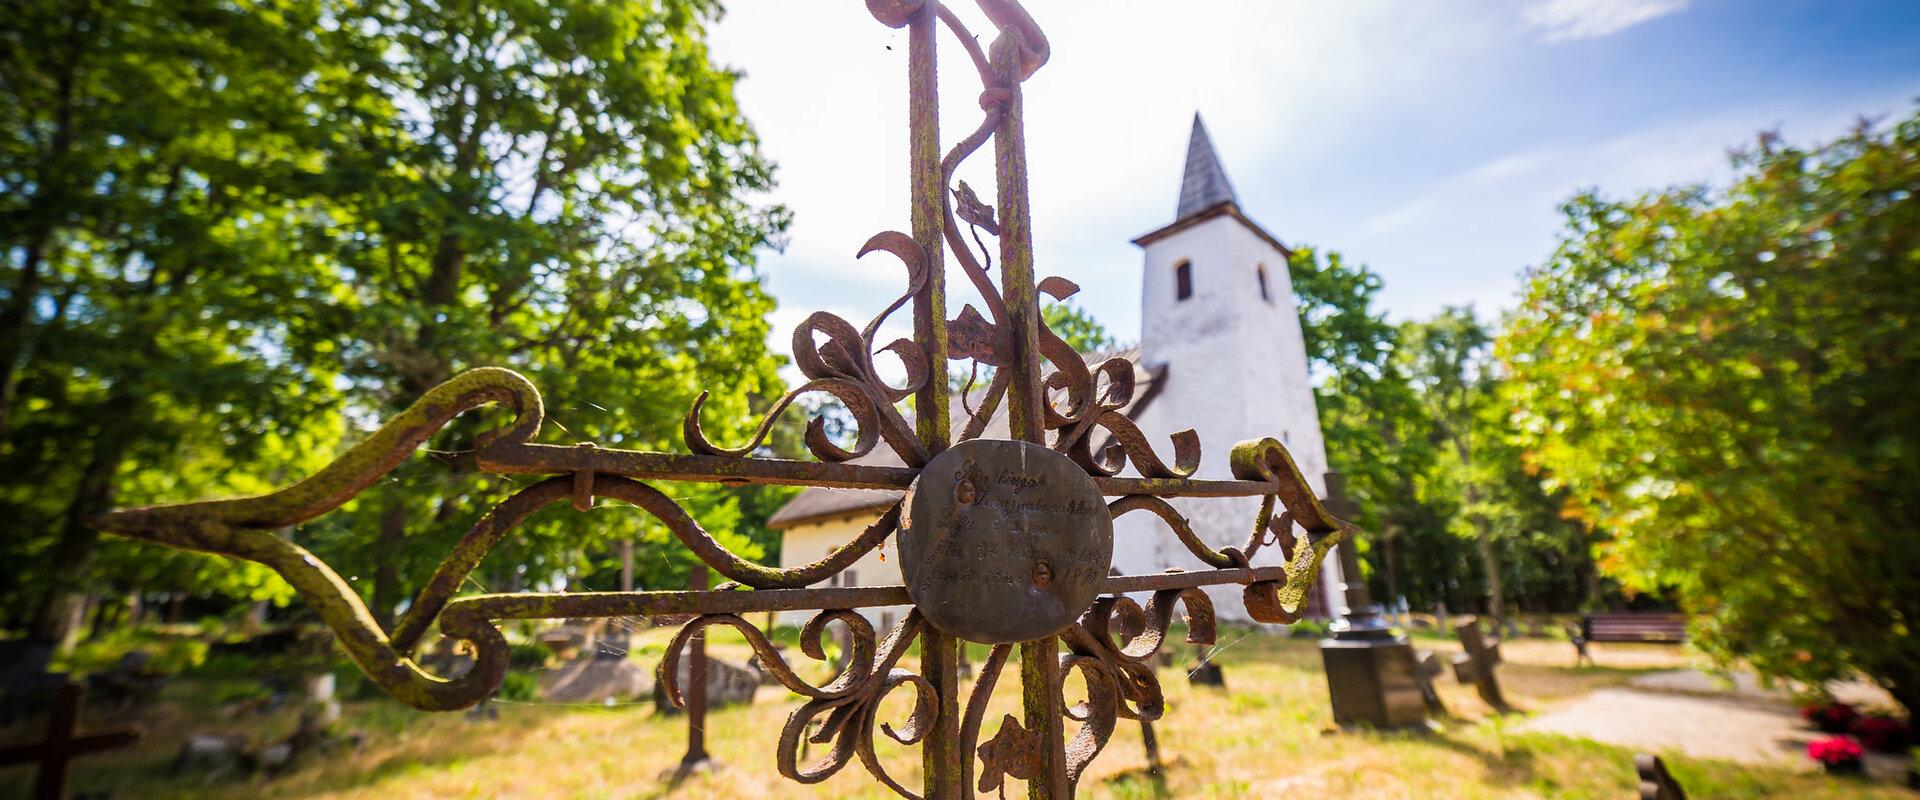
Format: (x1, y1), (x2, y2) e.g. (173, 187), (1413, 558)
(712, 0), (1920, 351)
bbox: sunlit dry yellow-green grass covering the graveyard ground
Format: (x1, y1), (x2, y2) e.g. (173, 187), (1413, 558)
(0, 629), (1912, 800)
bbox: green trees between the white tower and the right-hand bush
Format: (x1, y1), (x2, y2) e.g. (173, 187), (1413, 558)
(1288, 246), (1603, 616)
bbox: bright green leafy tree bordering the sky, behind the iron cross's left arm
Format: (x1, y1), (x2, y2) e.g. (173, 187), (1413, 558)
(289, 0), (787, 618)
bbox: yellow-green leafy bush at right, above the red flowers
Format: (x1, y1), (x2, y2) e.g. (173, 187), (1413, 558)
(1498, 113), (1920, 712)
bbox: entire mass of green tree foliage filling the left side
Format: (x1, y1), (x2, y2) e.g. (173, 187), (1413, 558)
(0, 0), (787, 635)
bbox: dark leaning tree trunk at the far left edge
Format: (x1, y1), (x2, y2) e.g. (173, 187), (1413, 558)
(29, 389), (140, 650)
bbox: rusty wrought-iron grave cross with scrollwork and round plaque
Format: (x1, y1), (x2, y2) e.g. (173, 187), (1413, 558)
(100, 0), (1354, 798)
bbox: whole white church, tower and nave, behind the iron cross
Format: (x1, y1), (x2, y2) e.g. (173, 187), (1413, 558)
(768, 115), (1342, 625)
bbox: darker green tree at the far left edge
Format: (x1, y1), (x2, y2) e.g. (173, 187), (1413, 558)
(0, 0), (346, 641)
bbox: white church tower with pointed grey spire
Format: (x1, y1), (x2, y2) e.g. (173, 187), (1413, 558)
(1114, 113), (1340, 620)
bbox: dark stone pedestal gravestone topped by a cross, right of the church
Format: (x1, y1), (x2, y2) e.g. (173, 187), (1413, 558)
(1319, 472), (1440, 727)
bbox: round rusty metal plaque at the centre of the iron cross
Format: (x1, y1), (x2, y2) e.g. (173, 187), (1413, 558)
(900, 439), (1114, 645)
